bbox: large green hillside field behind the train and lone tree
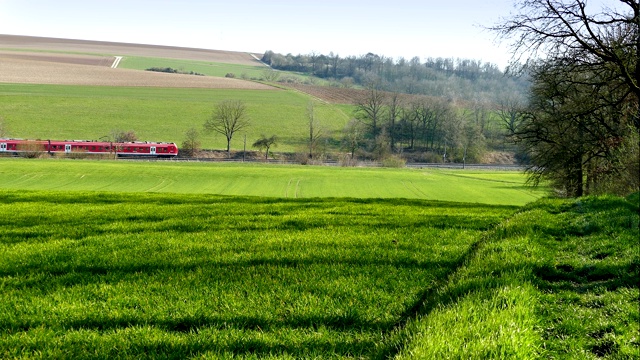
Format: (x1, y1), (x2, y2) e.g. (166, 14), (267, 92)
(0, 84), (351, 152)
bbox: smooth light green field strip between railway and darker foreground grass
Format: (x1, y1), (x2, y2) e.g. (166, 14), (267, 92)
(0, 158), (545, 205)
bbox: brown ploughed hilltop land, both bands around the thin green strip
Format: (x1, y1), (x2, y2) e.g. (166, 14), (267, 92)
(0, 35), (275, 90)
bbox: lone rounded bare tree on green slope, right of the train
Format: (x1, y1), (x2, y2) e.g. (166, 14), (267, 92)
(204, 100), (249, 157)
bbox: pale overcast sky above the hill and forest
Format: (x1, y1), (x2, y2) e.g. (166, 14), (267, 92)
(0, 0), (513, 68)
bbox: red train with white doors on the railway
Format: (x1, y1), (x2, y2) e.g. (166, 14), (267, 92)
(0, 139), (178, 157)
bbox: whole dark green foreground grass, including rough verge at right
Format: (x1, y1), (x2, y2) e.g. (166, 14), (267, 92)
(0, 190), (640, 359)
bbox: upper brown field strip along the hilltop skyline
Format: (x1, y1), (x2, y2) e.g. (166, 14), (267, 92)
(0, 34), (262, 65)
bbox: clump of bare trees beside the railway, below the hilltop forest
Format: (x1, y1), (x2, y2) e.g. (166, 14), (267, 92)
(342, 87), (505, 163)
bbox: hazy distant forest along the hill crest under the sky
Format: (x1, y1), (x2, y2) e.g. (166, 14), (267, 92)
(262, 51), (530, 103)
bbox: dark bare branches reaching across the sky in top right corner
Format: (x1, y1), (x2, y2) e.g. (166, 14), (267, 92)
(490, 0), (640, 132)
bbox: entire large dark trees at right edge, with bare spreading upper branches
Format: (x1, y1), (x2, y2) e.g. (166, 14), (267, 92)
(492, 0), (640, 196)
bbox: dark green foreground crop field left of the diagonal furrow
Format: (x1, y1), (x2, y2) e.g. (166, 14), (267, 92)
(0, 190), (516, 358)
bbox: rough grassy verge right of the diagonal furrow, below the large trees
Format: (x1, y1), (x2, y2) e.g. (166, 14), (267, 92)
(394, 194), (640, 359)
